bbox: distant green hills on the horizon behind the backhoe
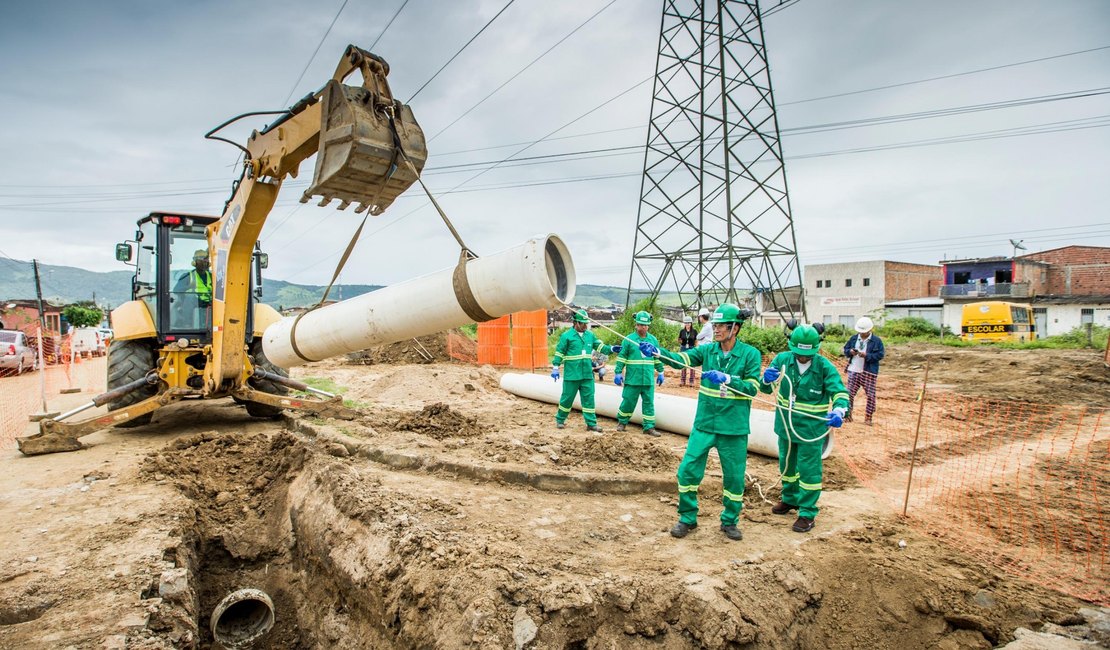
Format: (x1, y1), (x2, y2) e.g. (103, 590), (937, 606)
(0, 257), (643, 308)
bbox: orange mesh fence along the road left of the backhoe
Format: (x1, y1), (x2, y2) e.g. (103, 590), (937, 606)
(0, 335), (108, 449)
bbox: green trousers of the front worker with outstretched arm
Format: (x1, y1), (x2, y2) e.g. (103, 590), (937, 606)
(678, 427), (748, 526)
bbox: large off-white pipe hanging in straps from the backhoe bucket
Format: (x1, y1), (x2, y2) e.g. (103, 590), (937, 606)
(262, 235), (575, 368)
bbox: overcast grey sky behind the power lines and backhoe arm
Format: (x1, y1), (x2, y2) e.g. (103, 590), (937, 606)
(0, 0), (1110, 286)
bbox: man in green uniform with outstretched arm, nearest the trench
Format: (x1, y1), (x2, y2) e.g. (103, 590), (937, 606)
(639, 303), (760, 540)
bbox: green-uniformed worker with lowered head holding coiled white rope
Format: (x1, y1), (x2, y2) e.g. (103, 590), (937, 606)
(759, 325), (848, 532)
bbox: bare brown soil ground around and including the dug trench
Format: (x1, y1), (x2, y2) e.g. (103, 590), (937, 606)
(0, 344), (1108, 649)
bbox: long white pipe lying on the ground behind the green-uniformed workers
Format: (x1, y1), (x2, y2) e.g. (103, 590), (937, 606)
(501, 373), (833, 458)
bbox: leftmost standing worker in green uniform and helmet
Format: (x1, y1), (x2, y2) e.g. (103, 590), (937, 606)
(552, 309), (609, 434)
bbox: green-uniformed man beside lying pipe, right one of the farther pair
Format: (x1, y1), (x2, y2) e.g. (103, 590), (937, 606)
(612, 312), (663, 437)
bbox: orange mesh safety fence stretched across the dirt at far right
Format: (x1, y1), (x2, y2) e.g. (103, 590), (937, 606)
(836, 363), (1110, 605)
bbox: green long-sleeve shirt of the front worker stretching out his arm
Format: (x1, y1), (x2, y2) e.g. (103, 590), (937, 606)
(659, 341), (761, 436)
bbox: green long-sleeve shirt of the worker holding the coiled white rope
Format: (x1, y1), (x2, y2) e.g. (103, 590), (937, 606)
(759, 352), (848, 443)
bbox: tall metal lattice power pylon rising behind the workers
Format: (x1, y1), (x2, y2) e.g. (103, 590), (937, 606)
(626, 0), (801, 317)
